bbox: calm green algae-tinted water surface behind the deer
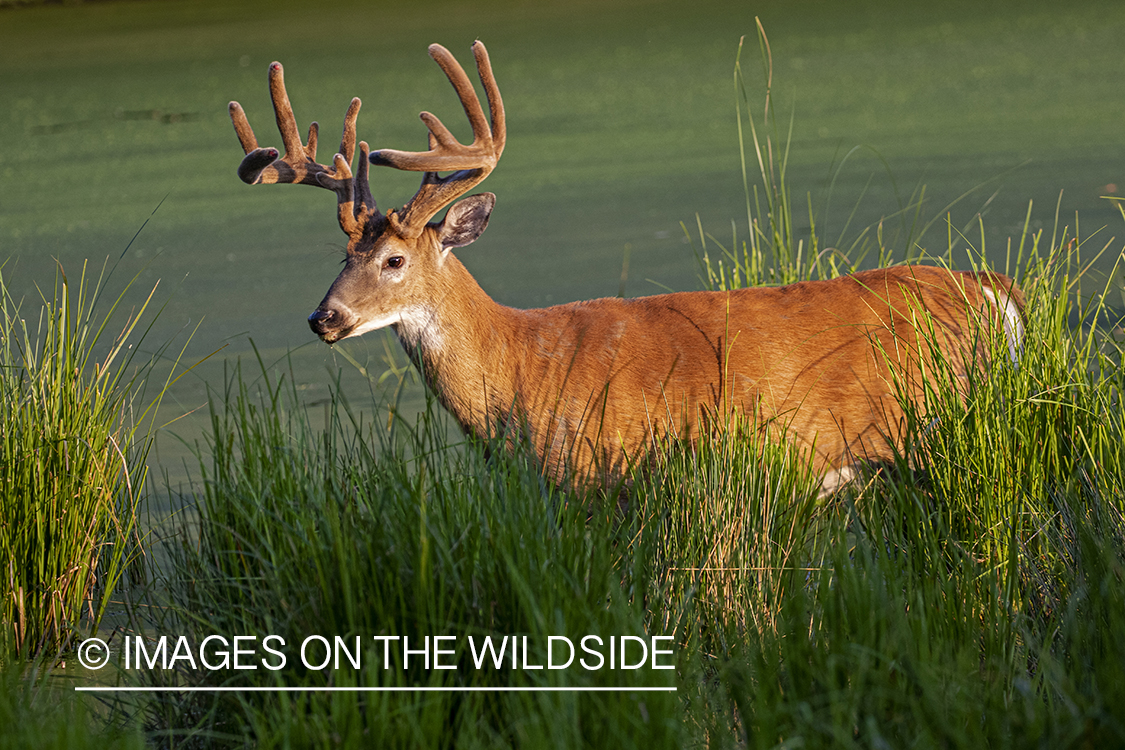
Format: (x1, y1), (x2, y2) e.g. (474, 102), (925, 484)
(0, 0), (1125, 488)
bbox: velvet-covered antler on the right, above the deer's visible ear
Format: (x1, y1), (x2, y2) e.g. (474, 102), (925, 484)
(371, 42), (506, 237)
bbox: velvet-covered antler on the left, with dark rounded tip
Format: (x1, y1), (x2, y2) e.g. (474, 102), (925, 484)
(230, 63), (381, 240)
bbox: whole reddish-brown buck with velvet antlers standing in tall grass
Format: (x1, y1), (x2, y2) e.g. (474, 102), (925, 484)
(230, 42), (1024, 495)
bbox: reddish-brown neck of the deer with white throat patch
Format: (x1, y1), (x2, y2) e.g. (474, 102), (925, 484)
(394, 254), (520, 435)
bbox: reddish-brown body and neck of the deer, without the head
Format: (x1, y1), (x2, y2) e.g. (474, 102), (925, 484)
(395, 259), (1010, 486)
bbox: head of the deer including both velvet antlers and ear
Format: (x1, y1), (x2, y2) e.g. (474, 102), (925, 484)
(231, 42), (505, 344)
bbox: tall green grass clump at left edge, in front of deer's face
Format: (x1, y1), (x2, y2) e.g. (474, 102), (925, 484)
(0, 260), (173, 658)
